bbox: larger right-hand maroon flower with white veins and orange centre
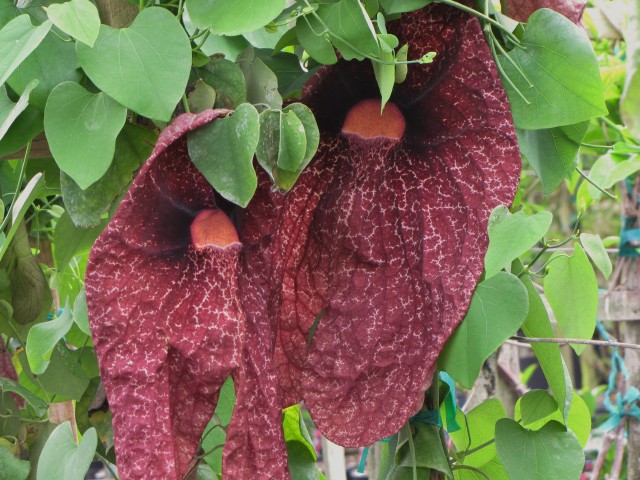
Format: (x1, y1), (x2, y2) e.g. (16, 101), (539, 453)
(270, 5), (520, 446)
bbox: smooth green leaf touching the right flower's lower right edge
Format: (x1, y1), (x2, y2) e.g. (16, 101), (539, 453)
(438, 272), (529, 388)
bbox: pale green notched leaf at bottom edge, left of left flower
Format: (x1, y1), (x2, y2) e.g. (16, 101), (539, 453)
(36, 422), (98, 480)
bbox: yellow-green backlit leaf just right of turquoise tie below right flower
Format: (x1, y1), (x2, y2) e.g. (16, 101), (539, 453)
(449, 398), (507, 468)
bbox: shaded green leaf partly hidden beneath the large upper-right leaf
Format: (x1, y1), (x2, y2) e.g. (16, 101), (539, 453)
(517, 122), (589, 195)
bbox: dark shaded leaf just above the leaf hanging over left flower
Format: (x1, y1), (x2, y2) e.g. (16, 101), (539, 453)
(196, 58), (247, 109)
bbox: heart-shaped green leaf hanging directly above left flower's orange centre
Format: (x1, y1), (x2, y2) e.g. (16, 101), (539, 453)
(187, 103), (260, 207)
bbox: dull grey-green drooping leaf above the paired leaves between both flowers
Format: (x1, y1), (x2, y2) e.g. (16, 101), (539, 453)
(236, 48), (282, 108)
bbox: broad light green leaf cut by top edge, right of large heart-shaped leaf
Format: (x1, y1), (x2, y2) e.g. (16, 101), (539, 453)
(186, 0), (286, 35)
